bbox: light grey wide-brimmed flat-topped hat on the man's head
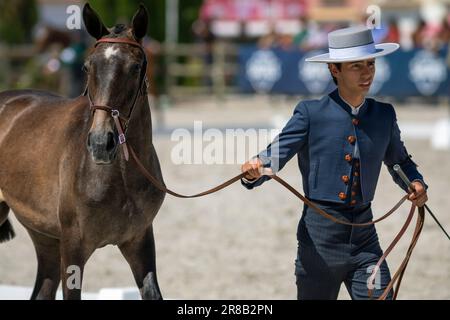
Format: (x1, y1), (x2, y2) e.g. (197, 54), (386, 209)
(306, 26), (400, 63)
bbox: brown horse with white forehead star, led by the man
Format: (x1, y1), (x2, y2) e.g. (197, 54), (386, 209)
(0, 4), (165, 300)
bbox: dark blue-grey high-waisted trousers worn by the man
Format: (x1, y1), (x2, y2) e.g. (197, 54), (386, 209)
(295, 203), (392, 300)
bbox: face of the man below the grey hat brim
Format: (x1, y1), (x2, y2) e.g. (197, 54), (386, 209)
(330, 59), (375, 95)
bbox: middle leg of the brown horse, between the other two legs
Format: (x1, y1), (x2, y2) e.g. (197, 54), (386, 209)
(60, 230), (86, 300)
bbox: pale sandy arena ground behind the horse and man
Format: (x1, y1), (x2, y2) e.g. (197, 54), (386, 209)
(0, 97), (450, 299)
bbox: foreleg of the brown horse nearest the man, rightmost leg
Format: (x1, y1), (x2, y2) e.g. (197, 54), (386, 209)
(119, 227), (162, 300)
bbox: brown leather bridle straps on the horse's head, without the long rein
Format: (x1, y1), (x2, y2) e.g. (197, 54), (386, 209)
(83, 38), (147, 161)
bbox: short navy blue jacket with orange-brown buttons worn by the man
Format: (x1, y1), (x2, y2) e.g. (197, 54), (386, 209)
(242, 89), (427, 203)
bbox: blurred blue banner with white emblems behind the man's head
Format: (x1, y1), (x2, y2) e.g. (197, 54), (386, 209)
(237, 46), (450, 98)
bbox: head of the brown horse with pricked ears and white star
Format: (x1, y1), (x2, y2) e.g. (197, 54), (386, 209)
(83, 4), (148, 164)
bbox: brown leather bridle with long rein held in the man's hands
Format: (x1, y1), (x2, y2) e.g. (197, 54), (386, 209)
(84, 38), (425, 300)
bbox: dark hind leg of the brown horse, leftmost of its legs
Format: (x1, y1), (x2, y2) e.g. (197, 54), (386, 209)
(27, 229), (61, 300)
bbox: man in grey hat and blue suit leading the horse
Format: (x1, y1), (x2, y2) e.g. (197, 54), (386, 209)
(241, 27), (427, 299)
